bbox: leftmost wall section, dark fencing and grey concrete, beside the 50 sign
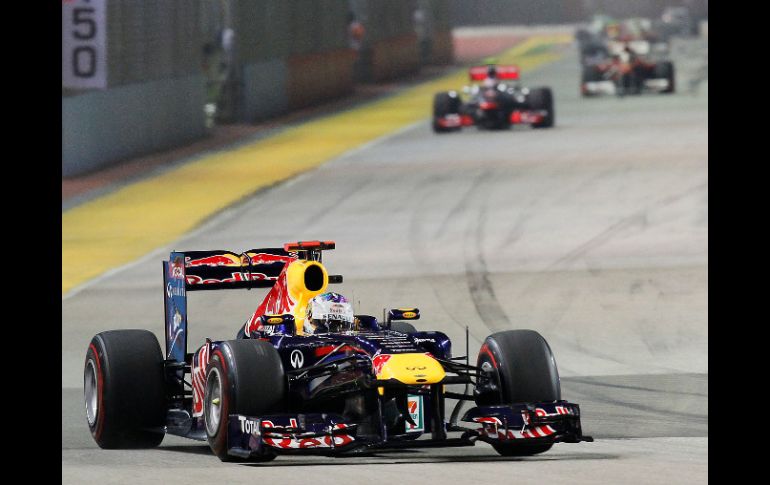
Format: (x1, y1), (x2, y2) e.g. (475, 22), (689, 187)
(62, 0), (205, 177)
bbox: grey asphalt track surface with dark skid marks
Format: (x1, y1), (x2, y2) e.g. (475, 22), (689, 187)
(62, 33), (708, 484)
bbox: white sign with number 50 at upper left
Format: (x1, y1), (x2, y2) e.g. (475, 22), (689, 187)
(61, 0), (107, 89)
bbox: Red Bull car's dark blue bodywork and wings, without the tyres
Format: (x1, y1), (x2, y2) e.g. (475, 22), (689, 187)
(141, 241), (591, 458)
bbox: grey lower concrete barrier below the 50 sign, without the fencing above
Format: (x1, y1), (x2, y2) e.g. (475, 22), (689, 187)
(62, 75), (205, 177)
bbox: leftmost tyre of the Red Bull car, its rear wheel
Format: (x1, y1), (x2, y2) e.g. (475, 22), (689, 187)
(83, 330), (167, 449)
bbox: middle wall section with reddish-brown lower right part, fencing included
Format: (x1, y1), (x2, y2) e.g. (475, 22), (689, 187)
(235, 0), (355, 122)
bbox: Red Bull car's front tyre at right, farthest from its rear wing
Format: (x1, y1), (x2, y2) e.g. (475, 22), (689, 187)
(476, 330), (561, 456)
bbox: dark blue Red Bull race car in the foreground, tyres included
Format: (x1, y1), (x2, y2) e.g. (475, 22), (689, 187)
(84, 241), (592, 461)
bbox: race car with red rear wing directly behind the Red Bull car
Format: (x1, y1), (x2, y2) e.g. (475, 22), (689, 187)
(433, 64), (556, 133)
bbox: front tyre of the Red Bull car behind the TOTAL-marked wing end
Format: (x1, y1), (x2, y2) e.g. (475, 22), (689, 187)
(203, 339), (286, 461)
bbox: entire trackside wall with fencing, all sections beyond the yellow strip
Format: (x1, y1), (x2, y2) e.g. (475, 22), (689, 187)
(62, 0), (452, 177)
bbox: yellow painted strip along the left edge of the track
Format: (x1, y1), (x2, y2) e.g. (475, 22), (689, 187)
(62, 35), (572, 296)
